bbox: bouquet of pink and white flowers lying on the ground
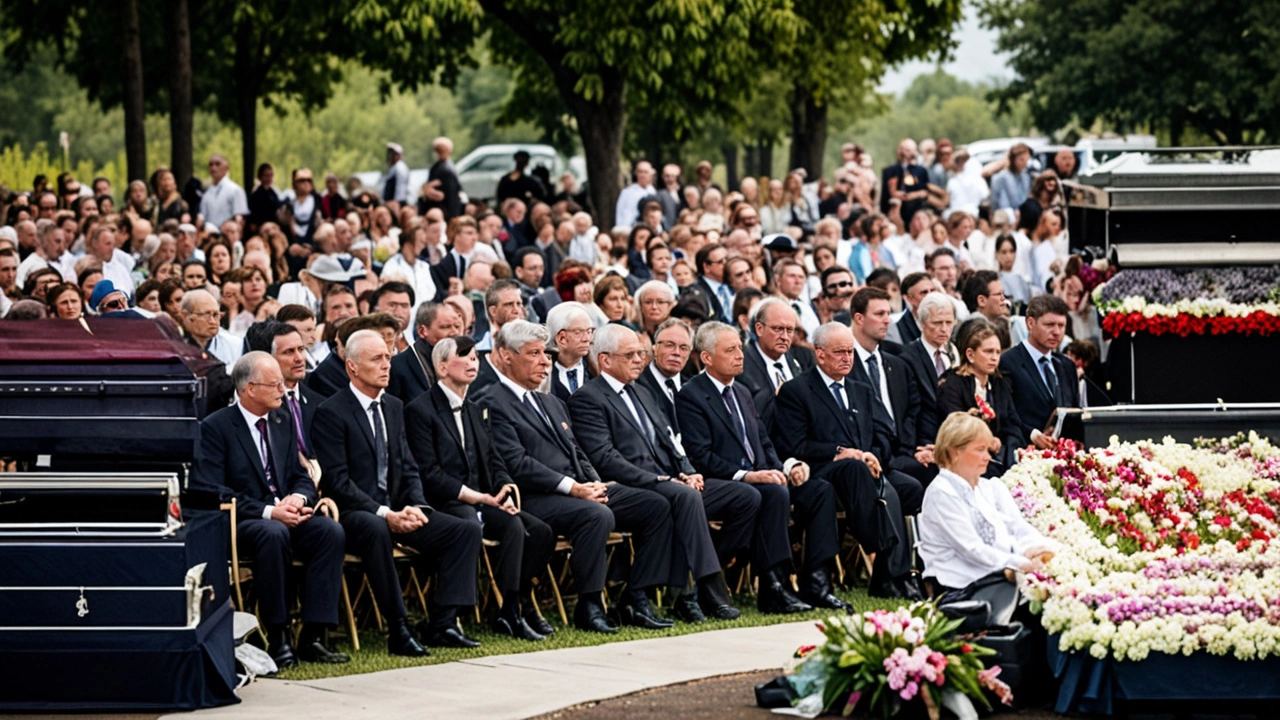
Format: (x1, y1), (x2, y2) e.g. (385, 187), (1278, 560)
(792, 602), (1012, 719)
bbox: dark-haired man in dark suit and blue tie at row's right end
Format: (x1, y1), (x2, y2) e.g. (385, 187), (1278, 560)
(1000, 295), (1080, 448)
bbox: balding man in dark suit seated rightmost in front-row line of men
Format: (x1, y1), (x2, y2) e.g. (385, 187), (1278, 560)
(773, 323), (924, 600)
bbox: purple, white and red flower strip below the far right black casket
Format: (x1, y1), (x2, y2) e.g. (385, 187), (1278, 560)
(1093, 266), (1280, 337)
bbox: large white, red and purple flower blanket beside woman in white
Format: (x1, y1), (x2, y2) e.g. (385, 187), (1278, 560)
(1004, 434), (1280, 661)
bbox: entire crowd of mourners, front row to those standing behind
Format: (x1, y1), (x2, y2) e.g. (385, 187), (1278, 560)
(0, 137), (1108, 665)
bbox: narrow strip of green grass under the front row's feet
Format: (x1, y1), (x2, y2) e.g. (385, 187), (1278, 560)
(279, 588), (901, 680)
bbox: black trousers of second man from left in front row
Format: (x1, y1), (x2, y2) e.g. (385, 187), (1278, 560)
(342, 510), (481, 623)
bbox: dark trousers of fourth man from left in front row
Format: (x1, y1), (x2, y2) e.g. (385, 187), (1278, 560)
(524, 483), (672, 593)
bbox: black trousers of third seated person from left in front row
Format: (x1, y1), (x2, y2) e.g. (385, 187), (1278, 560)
(436, 500), (556, 600)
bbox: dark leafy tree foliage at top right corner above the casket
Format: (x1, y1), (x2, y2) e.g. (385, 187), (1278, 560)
(979, 0), (1280, 145)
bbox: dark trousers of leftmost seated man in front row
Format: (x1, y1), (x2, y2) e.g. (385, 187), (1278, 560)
(236, 515), (346, 626)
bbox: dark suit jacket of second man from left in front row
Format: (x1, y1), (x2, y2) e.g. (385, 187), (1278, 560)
(312, 386), (426, 512)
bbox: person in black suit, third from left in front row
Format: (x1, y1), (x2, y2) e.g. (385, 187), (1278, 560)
(404, 336), (556, 641)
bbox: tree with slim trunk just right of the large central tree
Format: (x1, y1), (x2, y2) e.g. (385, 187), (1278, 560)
(777, 0), (961, 177)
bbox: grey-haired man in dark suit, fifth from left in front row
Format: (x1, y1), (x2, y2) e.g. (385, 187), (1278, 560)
(568, 324), (760, 623)
